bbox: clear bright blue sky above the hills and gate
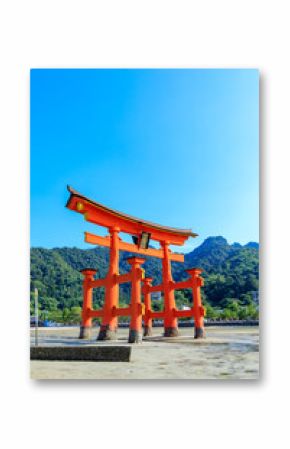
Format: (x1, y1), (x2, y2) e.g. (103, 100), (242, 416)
(31, 69), (259, 251)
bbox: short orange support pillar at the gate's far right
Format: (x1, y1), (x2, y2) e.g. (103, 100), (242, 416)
(186, 268), (205, 338)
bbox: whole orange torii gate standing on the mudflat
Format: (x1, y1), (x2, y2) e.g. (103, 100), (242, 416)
(66, 186), (204, 343)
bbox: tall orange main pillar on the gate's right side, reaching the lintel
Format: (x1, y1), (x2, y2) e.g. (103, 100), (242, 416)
(161, 241), (178, 337)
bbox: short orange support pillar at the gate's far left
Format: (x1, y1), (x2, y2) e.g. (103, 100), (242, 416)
(79, 268), (97, 339)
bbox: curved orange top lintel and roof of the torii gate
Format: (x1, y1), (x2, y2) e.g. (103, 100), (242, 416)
(66, 186), (198, 245)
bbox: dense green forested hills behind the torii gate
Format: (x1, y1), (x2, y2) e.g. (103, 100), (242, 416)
(31, 237), (259, 323)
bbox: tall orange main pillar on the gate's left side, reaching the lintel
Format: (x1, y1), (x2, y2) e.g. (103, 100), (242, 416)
(98, 227), (120, 340)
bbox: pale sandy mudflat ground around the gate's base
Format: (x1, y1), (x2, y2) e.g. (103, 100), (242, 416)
(30, 327), (259, 379)
